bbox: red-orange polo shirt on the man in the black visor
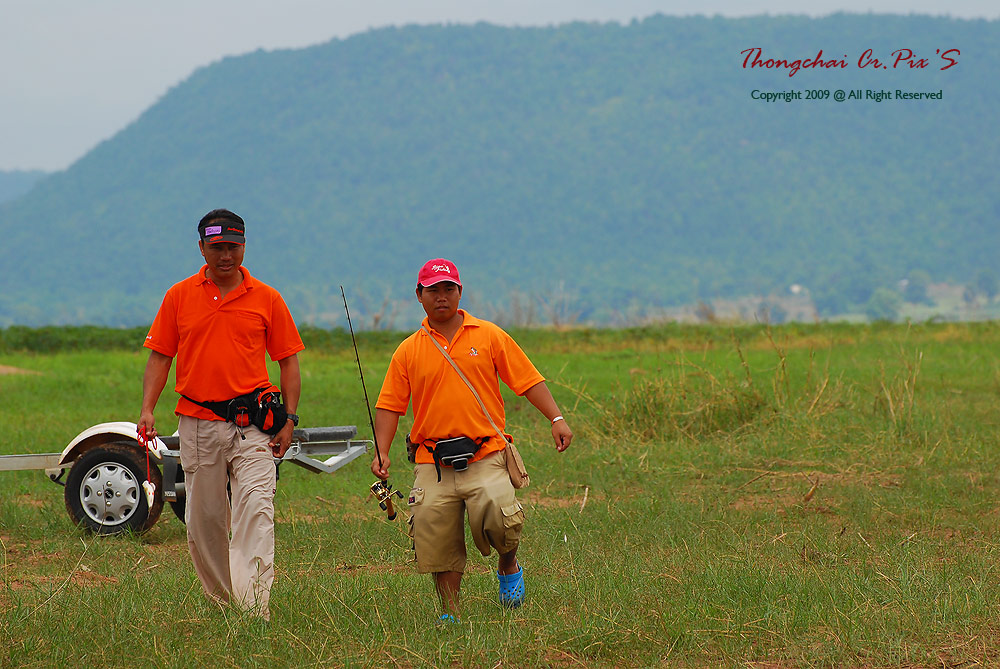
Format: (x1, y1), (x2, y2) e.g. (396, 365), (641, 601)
(143, 265), (305, 420)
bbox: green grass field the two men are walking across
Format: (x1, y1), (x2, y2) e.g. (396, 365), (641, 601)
(0, 322), (1000, 668)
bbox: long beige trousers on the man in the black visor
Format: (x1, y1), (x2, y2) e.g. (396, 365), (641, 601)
(178, 416), (276, 619)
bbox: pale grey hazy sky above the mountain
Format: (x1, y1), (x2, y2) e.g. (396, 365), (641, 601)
(0, 0), (1000, 170)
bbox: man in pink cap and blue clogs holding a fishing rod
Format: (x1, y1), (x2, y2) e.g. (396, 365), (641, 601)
(372, 258), (573, 622)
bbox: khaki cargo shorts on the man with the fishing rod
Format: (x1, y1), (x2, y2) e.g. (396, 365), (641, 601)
(409, 451), (524, 574)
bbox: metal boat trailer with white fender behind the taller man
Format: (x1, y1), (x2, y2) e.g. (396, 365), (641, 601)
(0, 421), (374, 534)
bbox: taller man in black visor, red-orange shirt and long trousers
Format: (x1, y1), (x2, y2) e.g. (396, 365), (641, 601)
(138, 209), (305, 619)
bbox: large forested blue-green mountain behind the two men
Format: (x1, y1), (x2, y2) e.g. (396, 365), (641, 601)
(0, 14), (1000, 325)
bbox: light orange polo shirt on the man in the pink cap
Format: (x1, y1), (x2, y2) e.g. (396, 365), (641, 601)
(375, 309), (545, 463)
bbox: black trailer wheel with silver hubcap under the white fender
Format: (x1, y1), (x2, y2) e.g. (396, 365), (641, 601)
(65, 441), (163, 534)
